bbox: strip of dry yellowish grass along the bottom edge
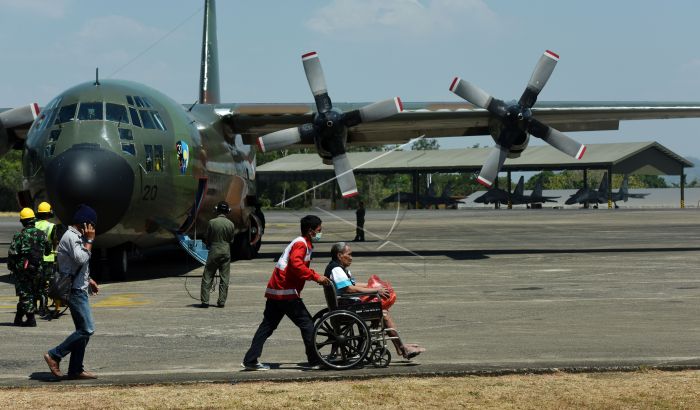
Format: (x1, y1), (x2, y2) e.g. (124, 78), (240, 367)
(0, 370), (700, 409)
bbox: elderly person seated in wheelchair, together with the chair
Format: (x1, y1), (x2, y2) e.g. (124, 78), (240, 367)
(314, 242), (425, 369)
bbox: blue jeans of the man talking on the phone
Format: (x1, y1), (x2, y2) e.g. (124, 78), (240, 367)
(49, 289), (95, 375)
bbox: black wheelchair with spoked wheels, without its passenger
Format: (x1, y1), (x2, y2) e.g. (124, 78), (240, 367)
(312, 284), (399, 370)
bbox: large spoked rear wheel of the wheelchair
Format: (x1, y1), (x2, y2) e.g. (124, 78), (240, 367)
(314, 310), (370, 370)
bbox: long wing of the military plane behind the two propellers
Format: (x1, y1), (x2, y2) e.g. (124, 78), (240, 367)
(217, 102), (700, 146)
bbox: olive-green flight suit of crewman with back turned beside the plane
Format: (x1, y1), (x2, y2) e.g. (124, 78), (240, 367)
(200, 215), (235, 306)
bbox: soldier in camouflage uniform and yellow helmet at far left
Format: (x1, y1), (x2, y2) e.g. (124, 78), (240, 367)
(7, 208), (51, 327)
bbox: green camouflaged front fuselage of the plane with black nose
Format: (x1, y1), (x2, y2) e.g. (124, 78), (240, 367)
(23, 80), (255, 248)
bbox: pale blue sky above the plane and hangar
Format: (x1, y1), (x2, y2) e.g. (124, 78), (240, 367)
(0, 0), (700, 165)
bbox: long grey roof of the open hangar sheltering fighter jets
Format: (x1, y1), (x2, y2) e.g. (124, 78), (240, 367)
(257, 142), (693, 176)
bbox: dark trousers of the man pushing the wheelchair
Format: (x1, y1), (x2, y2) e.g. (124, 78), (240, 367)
(243, 299), (319, 365)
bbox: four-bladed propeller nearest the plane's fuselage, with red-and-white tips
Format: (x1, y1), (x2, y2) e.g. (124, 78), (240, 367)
(258, 51), (403, 198)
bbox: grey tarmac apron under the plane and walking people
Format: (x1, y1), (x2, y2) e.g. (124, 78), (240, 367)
(0, 209), (700, 386)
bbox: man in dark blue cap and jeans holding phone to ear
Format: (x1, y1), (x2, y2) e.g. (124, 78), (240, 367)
(44, 205), (100, 379)
